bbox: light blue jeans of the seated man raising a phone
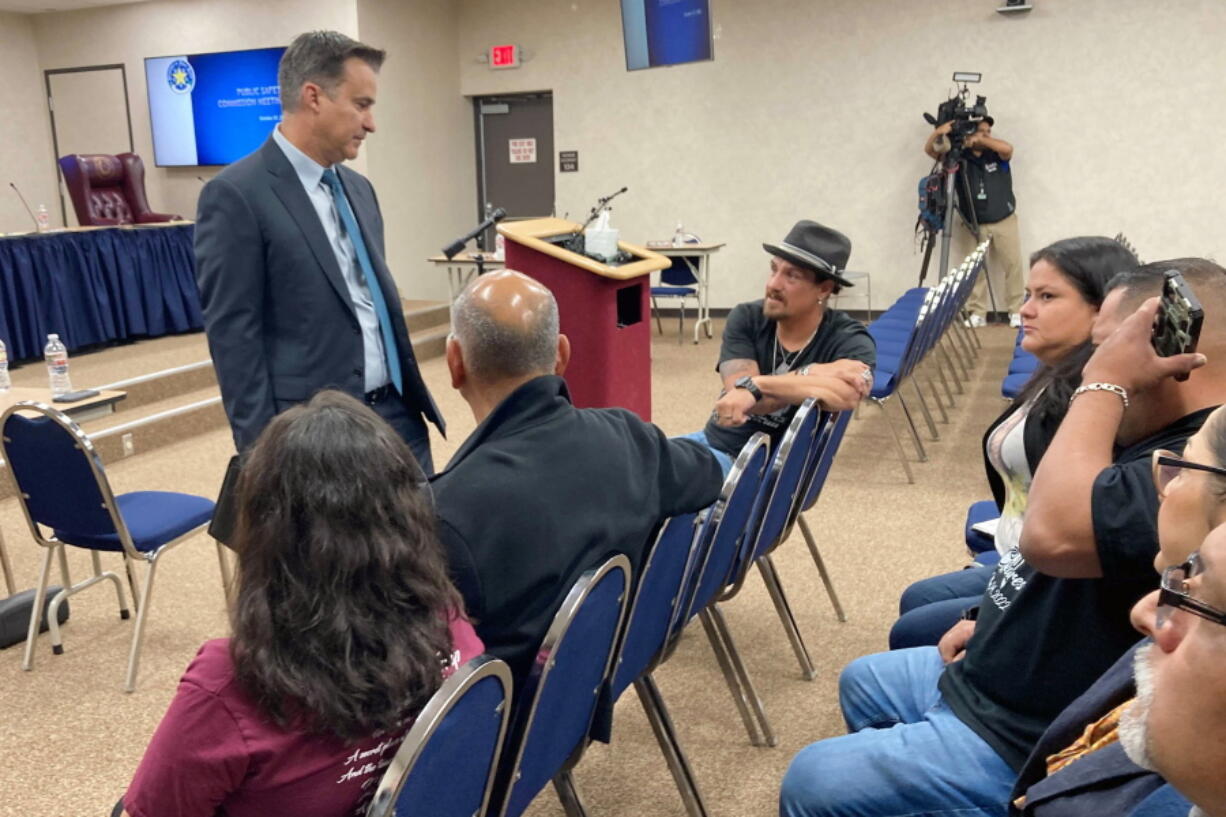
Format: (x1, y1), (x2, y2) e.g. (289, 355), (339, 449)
(779, 646), (1016, 817)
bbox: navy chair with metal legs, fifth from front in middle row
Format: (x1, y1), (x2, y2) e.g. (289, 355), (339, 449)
(718, 397), (830, 681)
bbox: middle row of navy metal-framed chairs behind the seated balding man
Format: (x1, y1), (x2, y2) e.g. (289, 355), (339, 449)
(368, 400), (851, 817)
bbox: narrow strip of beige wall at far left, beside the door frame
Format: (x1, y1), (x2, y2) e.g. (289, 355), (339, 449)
(0, 12), (59, 233)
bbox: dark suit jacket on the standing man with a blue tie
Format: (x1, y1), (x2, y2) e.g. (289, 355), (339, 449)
(195, 137), (444, 450)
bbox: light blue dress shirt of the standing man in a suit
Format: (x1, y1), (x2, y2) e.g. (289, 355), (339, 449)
(272, 128), (392, 391)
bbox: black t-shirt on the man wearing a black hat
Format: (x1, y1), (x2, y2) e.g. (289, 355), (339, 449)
(706, 299), (877, 458)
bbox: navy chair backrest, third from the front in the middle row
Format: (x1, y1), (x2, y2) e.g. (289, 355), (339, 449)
(609, 514), (700, 700)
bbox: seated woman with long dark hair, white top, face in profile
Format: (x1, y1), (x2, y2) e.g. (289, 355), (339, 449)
(890, 236), (1138, 649)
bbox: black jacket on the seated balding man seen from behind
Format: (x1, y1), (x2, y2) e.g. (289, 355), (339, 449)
(432, 375), (723, 689)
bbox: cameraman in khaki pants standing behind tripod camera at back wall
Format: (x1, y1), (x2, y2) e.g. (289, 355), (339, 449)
(923, 117), (1024, 328)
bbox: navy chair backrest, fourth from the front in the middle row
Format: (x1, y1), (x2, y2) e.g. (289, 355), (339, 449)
(674, 432), (770, 631)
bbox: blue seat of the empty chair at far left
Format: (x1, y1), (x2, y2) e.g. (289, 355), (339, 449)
(55, 491), (213, 553)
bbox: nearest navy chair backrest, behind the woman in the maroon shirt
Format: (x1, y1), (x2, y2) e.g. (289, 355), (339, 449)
(367, 655), (511, 817)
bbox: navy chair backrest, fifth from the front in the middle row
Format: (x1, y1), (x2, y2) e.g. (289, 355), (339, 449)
(733, 397), (829, 576)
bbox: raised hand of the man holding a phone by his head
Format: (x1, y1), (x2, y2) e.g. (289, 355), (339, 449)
(1081, 298), (1206, 395)
